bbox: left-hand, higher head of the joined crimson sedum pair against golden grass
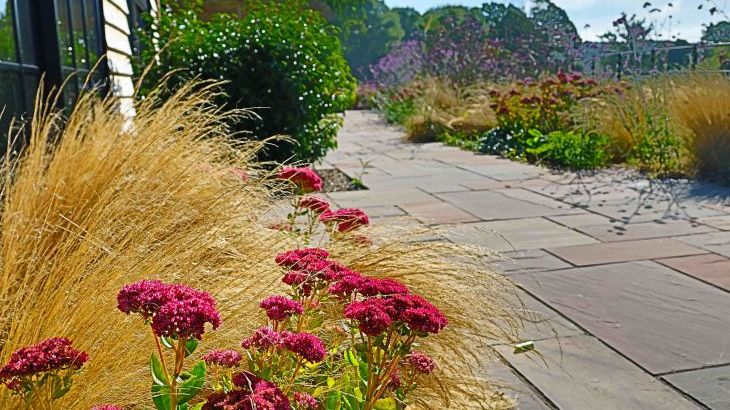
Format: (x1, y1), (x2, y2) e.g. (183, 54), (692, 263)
(117, 280), (170, 320)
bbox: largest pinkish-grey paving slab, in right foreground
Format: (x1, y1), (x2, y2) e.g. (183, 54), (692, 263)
(514, 262), (730, 374)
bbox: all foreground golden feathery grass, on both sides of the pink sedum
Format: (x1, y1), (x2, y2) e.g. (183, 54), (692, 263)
(0, 79), (521, 409)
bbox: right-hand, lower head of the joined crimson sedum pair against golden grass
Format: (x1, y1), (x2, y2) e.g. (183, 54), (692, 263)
(152, 285), (221, 339)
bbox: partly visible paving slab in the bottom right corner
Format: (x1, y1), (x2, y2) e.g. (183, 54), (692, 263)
(663, 366), (730, 410)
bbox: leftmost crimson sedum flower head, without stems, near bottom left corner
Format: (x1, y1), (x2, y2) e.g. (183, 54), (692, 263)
(0, 337), (89, 389)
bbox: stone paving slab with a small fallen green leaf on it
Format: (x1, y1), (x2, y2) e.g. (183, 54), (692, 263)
(498, 336), (700, 410)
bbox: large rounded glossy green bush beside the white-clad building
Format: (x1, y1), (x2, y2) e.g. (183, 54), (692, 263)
(140, 2), (355, 161)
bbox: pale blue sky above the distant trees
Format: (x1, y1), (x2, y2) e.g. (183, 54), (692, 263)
(385, 0), (730, 41)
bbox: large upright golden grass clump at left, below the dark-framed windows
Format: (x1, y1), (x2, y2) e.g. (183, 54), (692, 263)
(0, 83), (286, 409)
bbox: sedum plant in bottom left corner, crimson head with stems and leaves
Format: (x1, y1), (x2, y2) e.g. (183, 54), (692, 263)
(0, 337), (89, 407)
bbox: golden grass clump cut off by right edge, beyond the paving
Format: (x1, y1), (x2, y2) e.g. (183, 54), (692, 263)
(669, 74), (730, 180)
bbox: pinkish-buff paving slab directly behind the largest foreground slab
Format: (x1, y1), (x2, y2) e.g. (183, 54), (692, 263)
(547, 238), (707, 266)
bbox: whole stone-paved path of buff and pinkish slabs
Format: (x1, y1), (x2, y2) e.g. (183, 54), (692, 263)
(325, 111), (730, 410)
